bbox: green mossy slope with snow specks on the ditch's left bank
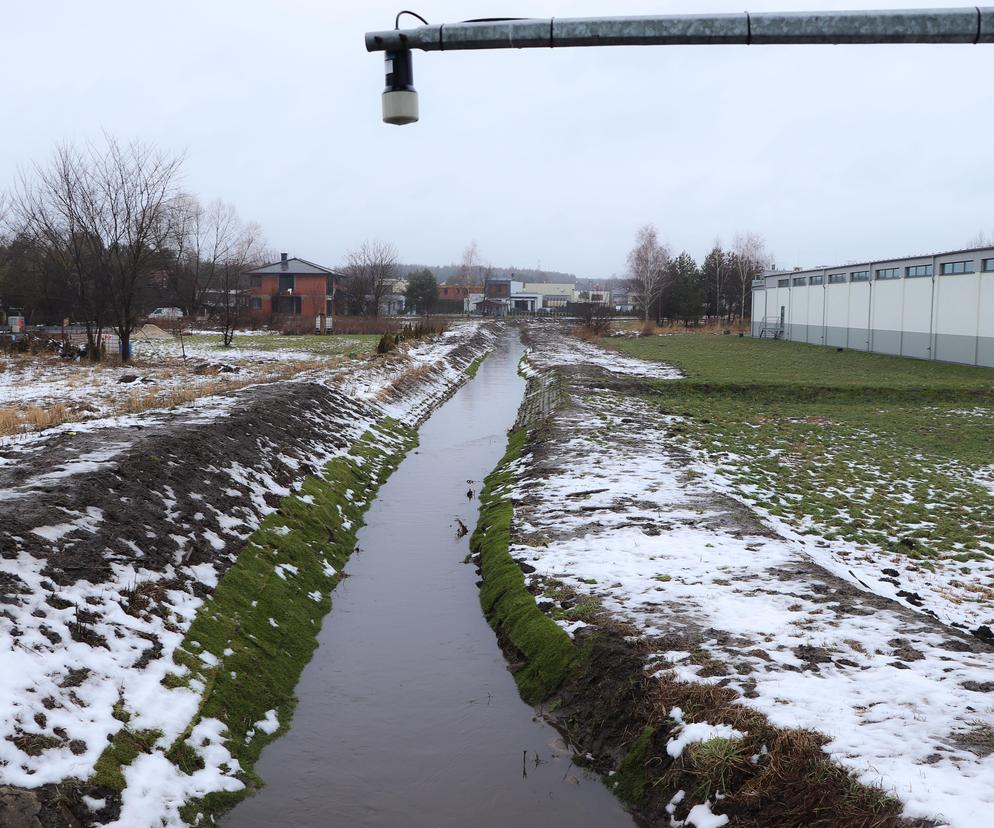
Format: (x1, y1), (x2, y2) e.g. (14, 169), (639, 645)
(91, 419), (417, 824)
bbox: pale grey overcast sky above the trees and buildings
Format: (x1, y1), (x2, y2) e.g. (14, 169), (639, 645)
(0, 0), (994, 277)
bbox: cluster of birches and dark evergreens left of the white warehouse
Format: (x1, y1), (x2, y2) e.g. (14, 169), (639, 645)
(627, 225), (772, 324)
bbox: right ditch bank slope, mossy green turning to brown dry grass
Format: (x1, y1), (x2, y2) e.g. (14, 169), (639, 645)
(472, 376), (901, 828)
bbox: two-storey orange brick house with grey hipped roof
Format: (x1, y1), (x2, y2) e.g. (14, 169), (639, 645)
(245, 253), (344, 319)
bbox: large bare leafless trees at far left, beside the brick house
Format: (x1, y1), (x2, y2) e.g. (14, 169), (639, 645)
(0, 137), (265, 360)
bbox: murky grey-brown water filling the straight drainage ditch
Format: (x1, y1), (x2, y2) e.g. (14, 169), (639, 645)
(224, 333), (633, 828)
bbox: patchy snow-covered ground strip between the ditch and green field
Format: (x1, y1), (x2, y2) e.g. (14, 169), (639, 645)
(512, 328), (994, 828)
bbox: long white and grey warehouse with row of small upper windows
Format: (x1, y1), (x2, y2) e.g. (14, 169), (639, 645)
(752, 247), (994, 367)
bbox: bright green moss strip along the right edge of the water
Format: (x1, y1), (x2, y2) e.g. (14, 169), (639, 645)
(471, 429), (580, 704)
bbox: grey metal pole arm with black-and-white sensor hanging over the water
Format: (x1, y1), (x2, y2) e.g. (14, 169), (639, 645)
(366, 6), (994, 124)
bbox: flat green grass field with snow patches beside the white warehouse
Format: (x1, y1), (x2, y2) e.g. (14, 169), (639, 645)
(604, 334), (994, 584)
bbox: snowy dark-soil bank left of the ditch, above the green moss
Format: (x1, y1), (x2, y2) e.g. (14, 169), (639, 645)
(0, 316), (495, 828)
